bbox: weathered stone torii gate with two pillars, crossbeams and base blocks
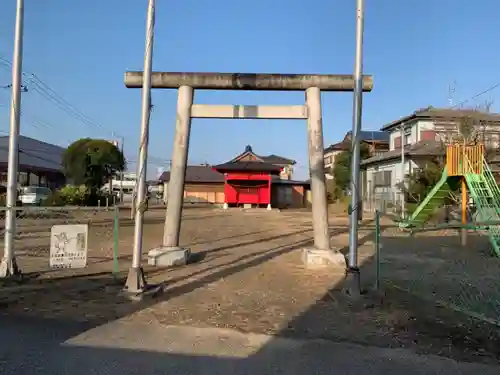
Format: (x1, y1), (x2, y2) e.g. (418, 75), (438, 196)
(125, 72), (373, 266)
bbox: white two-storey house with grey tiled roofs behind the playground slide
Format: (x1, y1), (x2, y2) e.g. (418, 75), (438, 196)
(361, 107), (500, 204)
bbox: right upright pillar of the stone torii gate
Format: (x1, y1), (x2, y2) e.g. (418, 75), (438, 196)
(306, 87), (330, 250)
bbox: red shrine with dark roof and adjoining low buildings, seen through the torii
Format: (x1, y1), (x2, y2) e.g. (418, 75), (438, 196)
(160, 146), (310, 209)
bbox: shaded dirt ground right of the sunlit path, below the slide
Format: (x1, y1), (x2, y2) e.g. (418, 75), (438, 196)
(274, 225), (500, 363)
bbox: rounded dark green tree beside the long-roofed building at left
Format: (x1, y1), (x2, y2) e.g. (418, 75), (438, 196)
(63, 138), (126, 190)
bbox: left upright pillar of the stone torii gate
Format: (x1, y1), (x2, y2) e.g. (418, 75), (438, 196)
(163, 86), (194, 249)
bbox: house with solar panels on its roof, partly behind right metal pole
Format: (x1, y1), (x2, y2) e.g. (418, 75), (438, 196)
(324, 130), (389, 179)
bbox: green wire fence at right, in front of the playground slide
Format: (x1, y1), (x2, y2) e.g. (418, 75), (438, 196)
(373, 212), (500, 326)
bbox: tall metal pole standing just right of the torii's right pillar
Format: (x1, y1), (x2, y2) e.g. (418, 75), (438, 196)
(347, 0), (364, 295)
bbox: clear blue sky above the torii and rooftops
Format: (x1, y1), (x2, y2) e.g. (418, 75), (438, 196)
(0, 0), (500, 177)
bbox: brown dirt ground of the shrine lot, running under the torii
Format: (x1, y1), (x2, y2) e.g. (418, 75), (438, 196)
(0, 208), (500, 362)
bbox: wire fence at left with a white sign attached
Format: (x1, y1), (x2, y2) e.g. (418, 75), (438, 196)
(0, 207), (120, 277)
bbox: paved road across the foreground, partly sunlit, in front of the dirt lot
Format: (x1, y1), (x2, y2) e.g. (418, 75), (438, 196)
(0, 316), (500, 375)
